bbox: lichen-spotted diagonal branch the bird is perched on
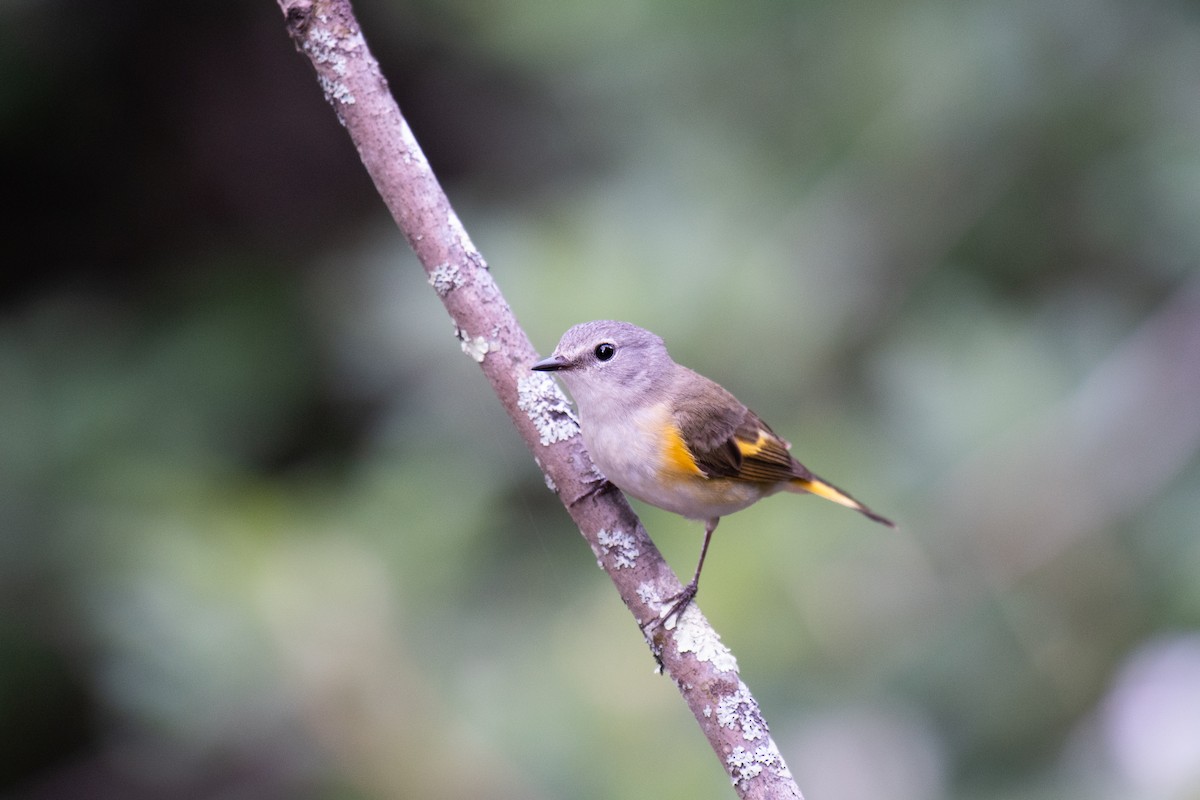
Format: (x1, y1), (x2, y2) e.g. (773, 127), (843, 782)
(277, 0), (802, 800)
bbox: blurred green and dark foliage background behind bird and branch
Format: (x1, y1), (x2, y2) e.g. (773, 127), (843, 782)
(0, 0), (1200, 800)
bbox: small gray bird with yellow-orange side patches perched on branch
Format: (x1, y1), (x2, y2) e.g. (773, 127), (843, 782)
(530, 320), (895, 630)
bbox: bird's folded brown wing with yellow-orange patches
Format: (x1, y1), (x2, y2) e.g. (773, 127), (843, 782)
(676, 373), (812, 483)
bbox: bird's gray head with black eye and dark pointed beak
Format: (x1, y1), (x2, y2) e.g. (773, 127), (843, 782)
(532, 319), (674, 416)
